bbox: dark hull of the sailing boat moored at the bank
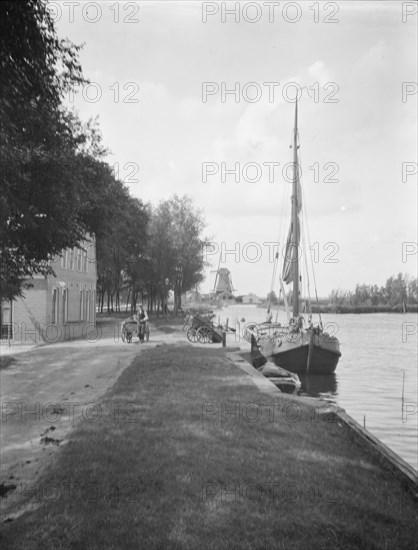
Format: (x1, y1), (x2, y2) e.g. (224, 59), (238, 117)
(254, 331), (341, 374)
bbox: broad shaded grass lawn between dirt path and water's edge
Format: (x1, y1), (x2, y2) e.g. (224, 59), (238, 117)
(1, 345), (417, 550)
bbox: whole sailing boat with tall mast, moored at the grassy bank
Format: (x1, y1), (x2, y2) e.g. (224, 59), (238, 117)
(247, 101), (341, 374)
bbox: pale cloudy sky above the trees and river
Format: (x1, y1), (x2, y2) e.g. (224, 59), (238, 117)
(54, 1), (418, 296)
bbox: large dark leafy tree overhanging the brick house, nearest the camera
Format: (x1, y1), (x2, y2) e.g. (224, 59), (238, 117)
(0, 0), (103, 299)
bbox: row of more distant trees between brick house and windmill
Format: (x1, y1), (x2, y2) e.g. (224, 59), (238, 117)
(98, 195), (204, 311)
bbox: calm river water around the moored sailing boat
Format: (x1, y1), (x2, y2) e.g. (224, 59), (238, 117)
(219, 305), (418, 470)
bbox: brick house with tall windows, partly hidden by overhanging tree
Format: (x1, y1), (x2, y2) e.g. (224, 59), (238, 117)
(1, 238), (97, 343)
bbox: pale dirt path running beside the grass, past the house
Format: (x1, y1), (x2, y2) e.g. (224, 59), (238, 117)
(0, 321), (182, 520)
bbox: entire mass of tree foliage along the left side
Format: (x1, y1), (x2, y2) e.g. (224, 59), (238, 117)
(0, 0), (207, 311)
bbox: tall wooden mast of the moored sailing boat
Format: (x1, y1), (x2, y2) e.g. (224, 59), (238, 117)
(292, 98), (299, 318)
